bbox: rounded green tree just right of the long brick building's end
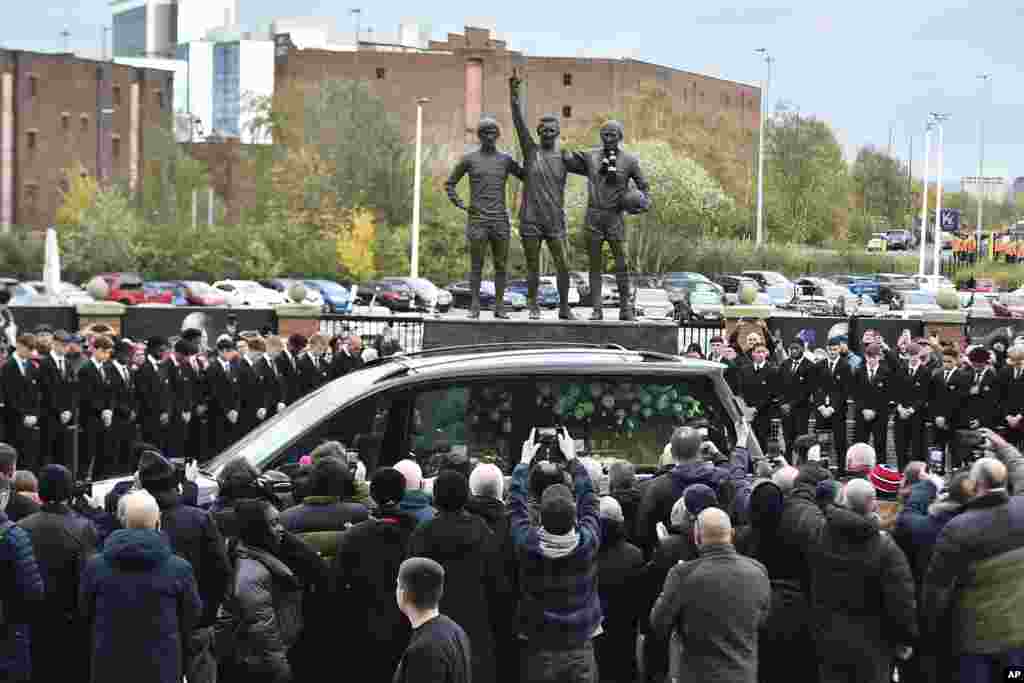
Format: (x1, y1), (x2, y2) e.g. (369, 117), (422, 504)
(765, 104), (850, 245)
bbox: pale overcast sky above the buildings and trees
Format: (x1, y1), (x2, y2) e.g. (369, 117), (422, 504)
(6, 0), (1024, 187)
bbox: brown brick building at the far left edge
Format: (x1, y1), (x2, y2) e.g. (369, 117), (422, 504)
(0, 49), (173, 230)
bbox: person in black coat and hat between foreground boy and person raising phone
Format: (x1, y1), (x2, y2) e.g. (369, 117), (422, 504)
(409, 470), (512, 681)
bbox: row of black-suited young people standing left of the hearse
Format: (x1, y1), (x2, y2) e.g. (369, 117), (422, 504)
(0, 326), (379, 480)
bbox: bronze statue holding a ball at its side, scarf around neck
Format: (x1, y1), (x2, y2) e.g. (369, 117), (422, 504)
(568, 121), (650, 321)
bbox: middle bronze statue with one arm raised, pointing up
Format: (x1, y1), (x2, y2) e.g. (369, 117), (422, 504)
(509, 70), (585, 321)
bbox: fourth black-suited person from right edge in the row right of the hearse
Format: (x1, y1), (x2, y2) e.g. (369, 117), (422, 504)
(893, 343), (932, 472)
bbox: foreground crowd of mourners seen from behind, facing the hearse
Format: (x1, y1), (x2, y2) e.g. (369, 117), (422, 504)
(0, 417), (1024, 683)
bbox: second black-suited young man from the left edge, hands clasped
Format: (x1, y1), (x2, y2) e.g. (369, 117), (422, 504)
(39, 330), (78, 467)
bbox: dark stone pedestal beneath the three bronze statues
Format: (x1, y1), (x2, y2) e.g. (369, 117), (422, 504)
(423, 317), (679, 355)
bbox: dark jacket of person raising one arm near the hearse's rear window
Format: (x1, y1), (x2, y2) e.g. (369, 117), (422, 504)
(636, 447), (750, 555)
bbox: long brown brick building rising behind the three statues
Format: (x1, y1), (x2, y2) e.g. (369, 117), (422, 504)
(274, 27), (761, 159)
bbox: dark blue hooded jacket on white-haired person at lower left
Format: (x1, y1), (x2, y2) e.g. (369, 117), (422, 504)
(81, 529), (203, 683)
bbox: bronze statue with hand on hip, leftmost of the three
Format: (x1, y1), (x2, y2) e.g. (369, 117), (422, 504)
(444, 117), (523, 318)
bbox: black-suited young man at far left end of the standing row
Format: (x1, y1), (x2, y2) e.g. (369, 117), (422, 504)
(0, 335), (42, 472)
